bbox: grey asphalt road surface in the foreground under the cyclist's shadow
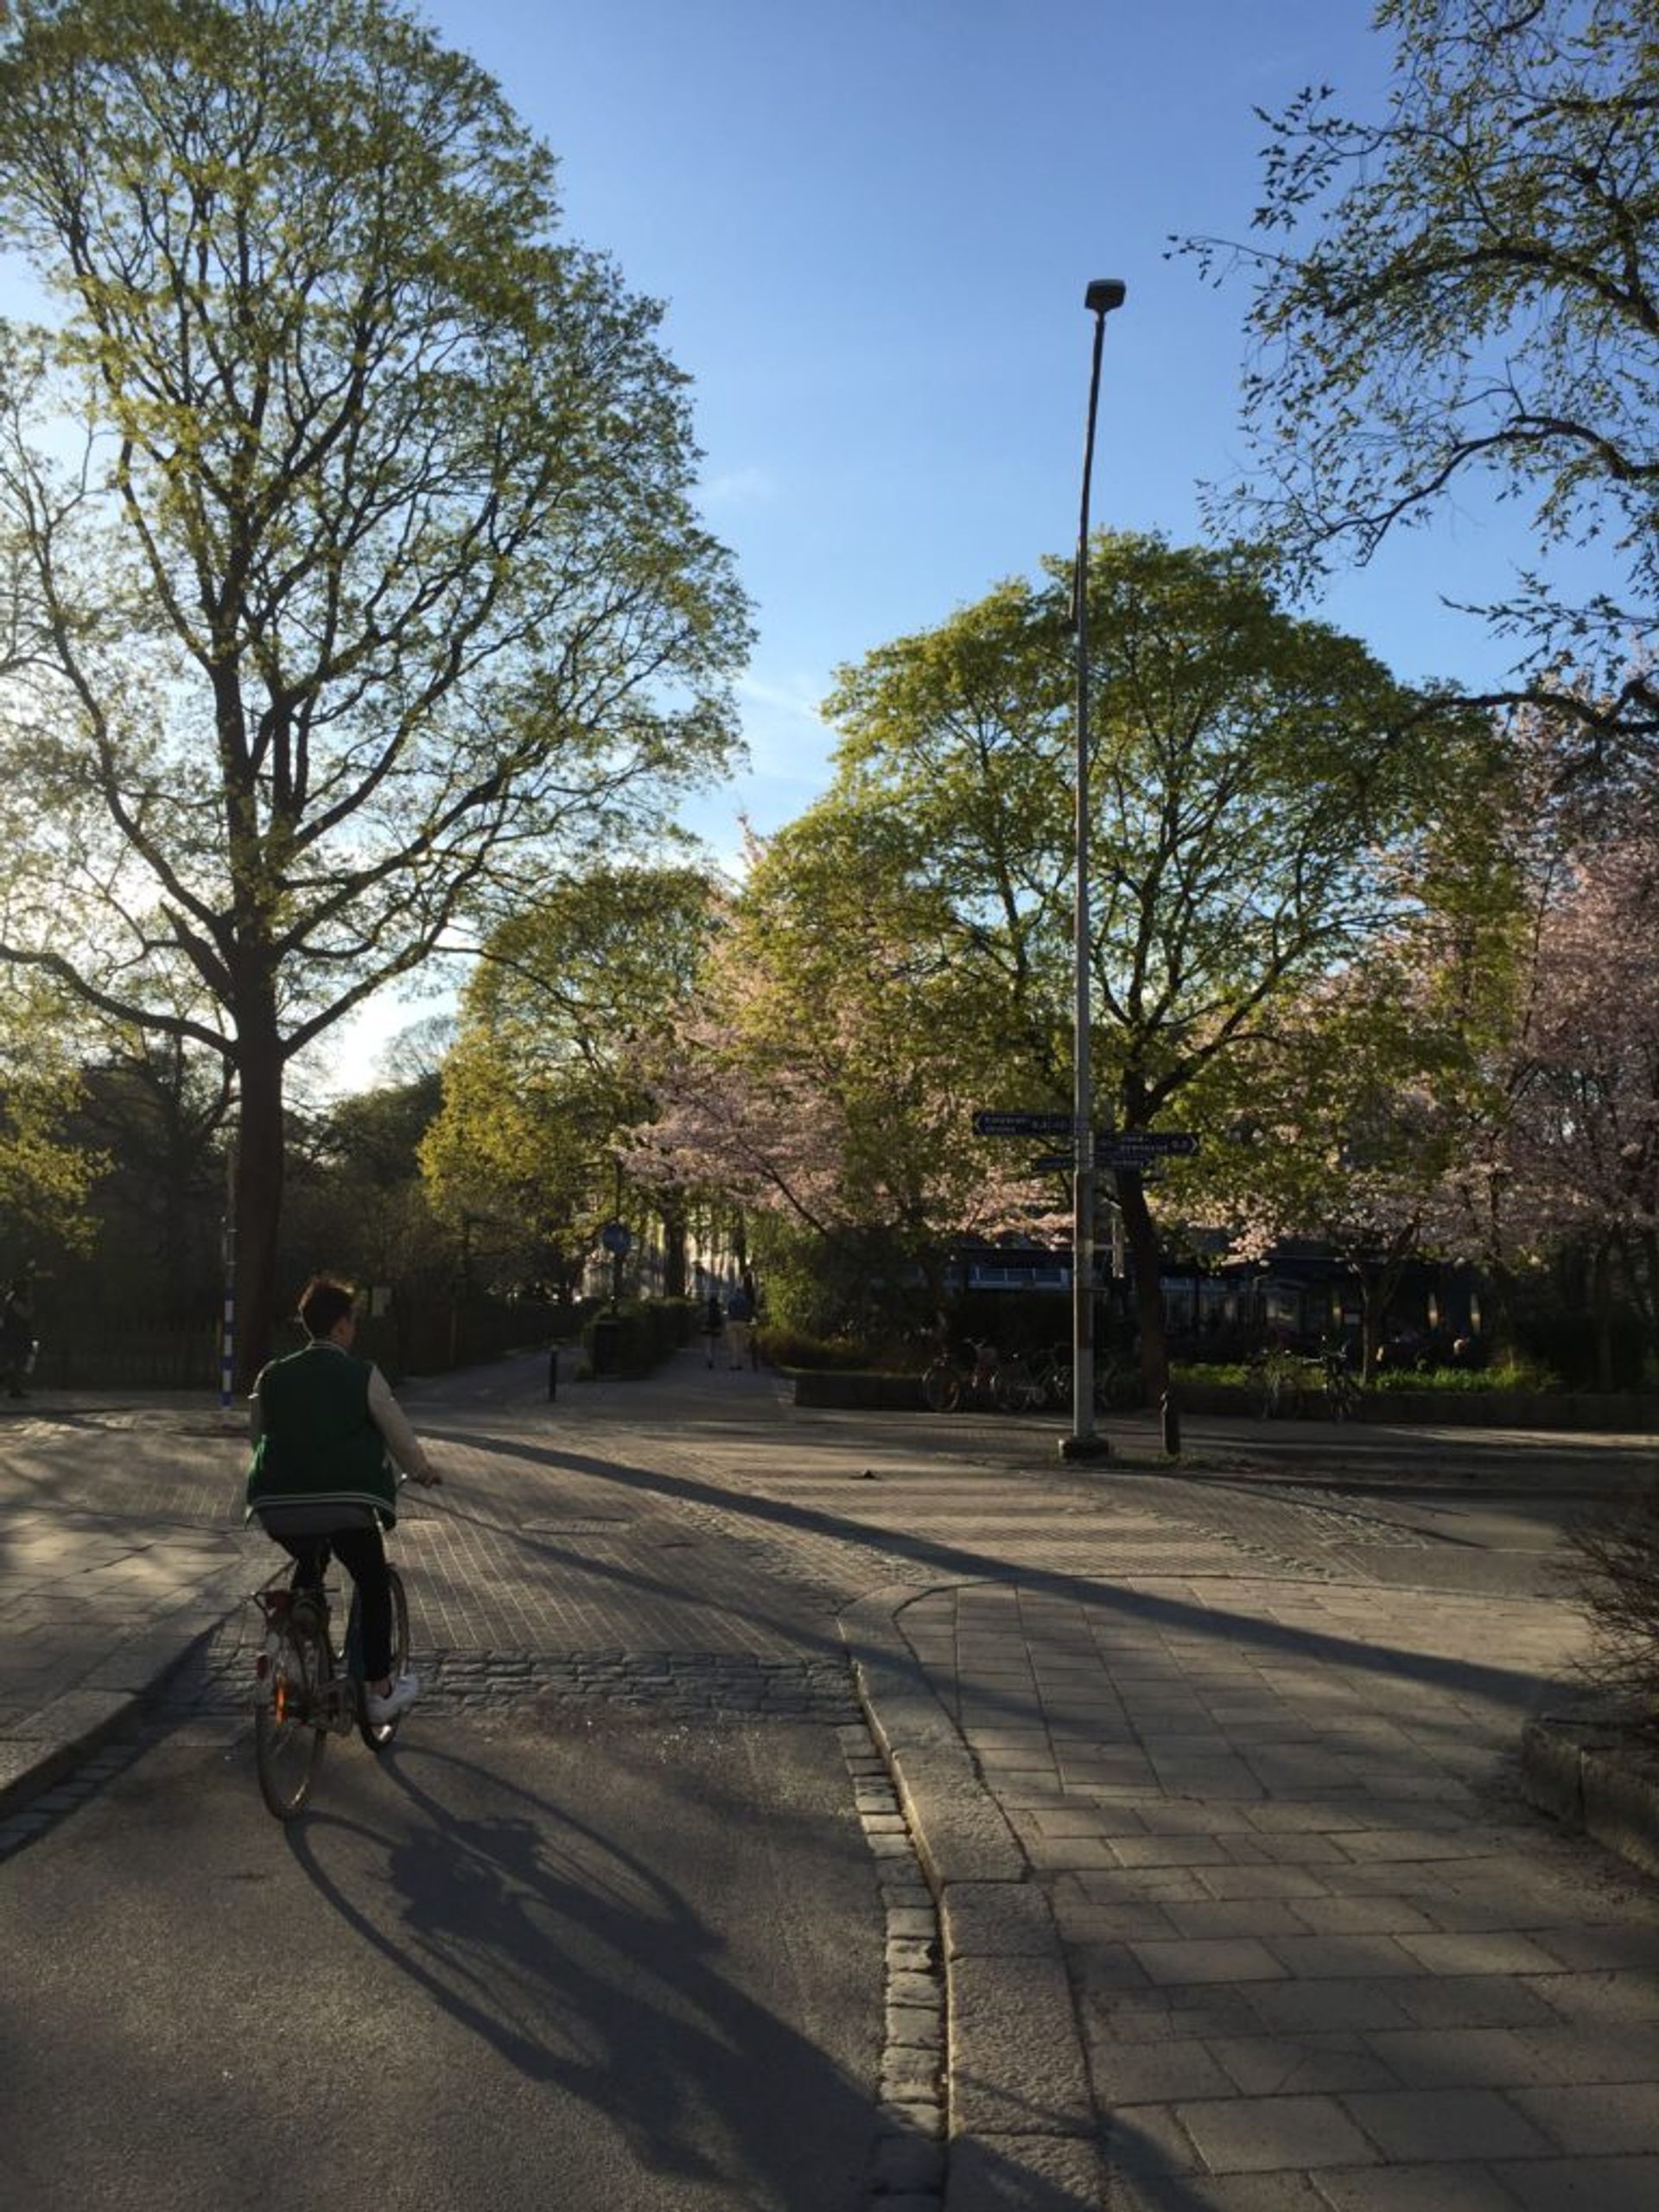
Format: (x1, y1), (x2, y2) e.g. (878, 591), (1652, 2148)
(0, 1701), (882, 2212)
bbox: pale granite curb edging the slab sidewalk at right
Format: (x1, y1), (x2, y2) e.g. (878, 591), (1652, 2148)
(841, 1584), (1106, 2212)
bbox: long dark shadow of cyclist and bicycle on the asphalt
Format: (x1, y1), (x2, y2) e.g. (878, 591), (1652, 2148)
(285, 1745), (880, 2201)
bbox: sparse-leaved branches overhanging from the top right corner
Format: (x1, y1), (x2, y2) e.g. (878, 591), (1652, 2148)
(1185, 0), (1659, 743)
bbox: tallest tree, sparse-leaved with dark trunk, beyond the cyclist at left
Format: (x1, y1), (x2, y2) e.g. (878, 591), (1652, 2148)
(0, 0), (746, 1363)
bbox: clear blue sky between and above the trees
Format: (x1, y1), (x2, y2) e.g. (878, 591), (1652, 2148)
(431, 0), (1530, 854)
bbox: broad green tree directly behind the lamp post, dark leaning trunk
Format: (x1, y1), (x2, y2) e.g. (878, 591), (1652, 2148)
(823, 536), (1486, 1391)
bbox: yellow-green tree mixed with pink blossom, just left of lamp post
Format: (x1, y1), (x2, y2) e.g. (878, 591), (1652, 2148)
(639, 814), (1039, 1323)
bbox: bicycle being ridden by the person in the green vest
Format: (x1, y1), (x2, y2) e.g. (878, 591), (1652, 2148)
(252, 1566), (410, 1821)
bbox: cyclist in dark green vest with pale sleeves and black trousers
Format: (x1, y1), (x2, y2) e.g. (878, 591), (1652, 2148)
(248, 1274), (442, 1727)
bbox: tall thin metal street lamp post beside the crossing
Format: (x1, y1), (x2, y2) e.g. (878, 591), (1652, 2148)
(1059, 276), (1126, 1460)
